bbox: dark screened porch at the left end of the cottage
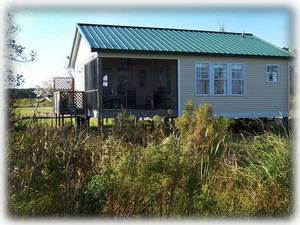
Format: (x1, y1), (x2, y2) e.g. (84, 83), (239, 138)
(84, 58), (178, 116)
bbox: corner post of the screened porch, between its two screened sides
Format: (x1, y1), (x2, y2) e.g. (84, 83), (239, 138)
(97, 56), (103, 132)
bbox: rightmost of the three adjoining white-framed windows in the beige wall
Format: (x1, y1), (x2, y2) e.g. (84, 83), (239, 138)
(231, 64), (244, 95)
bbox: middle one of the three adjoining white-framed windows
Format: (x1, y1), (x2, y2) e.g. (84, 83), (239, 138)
(214, 64), (227, 95)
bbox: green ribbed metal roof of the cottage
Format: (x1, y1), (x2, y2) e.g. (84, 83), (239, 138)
(77, 24), (290, 58)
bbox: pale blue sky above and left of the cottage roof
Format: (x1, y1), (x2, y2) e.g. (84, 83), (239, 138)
(10, 7), (293, 88)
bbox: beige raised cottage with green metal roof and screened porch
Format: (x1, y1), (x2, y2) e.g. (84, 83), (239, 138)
(54, 24), (290, 127)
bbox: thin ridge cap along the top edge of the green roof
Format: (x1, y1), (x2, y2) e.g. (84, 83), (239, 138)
(77, 23), (253, 36)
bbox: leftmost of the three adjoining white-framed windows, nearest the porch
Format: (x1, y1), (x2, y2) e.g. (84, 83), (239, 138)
(196, 63), (209, 95)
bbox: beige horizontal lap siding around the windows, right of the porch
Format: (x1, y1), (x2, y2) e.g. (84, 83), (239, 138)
(180, 57), (288, 116)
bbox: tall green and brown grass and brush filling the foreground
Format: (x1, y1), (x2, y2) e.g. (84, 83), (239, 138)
(8, 104), (293, 217)
